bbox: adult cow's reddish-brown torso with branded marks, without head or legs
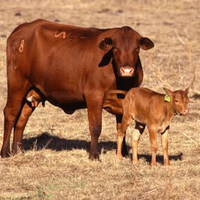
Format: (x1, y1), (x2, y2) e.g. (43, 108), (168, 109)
(7, 20), (115, 107)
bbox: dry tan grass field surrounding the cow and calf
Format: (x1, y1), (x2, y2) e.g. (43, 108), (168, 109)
(0, 0), (200, 200)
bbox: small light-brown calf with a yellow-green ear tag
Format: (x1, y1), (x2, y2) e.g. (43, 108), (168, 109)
(111, 87), (189, 166)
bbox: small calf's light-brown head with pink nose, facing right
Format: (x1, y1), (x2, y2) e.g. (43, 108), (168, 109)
(164, 88), (189, 115)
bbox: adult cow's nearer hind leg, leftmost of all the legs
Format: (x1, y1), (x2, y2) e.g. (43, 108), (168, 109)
(1, 81), (30, 157)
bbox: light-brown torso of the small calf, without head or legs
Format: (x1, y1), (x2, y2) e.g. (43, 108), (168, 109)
(122, 88), (171, 125)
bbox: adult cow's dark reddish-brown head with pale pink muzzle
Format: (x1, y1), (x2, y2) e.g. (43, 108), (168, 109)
(99, 27), (154, 77)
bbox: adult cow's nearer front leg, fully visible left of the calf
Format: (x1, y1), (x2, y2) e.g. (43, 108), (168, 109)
(86, 94), (103, 159)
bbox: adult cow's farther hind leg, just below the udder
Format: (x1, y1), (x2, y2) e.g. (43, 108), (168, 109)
(12, 102), (35, 154)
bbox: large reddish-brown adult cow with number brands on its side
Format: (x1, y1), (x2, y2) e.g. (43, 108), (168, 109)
(1, 20), (154, 158)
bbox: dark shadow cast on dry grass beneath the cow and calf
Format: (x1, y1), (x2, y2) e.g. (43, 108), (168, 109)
(23, 132), (183, 164)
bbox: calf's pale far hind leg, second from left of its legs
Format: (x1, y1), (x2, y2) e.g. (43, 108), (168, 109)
(131, 122), (145, 165)
